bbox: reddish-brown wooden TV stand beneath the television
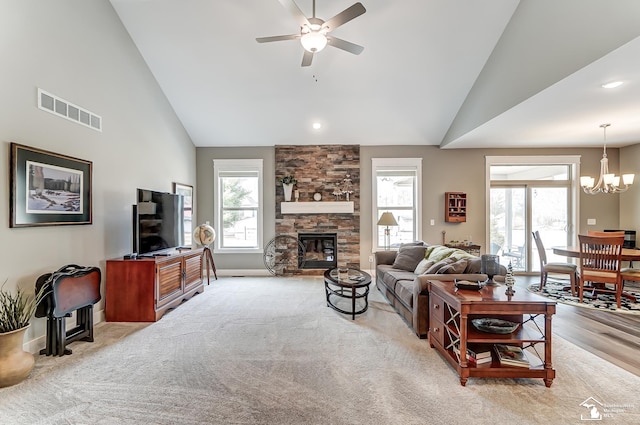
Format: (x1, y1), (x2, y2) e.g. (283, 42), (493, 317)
(105, 245), (204, 322)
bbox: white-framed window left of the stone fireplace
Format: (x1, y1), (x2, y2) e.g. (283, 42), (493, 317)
(213, 159), (263, 252)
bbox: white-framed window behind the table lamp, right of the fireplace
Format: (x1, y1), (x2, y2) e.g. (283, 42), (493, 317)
(371, 158), (422, 251)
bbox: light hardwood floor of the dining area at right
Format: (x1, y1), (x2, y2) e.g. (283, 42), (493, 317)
(516, 276), (640, 376)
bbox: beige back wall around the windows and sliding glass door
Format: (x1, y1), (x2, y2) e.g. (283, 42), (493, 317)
(197, 145), (640, 270)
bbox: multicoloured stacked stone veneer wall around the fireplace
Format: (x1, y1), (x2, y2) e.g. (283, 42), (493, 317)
(275, 145), (360, 275)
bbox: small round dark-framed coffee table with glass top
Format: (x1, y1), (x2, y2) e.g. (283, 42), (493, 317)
(324, 268), (371, 320)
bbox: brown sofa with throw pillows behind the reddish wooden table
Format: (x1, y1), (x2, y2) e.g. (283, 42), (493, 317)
(375, 243), (507, 338)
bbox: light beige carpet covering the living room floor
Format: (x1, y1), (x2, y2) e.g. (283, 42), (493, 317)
(0, 277), (640, 425)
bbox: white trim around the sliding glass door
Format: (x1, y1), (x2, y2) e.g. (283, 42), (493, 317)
(485, 155), (580, 246)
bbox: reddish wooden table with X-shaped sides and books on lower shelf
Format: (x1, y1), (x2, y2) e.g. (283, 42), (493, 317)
(429, 281), (556, 387)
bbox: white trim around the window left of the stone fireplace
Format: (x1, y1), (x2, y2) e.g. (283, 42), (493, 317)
(213, 159), (264, 254)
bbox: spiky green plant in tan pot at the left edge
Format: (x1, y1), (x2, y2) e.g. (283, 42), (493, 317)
(0, 281), (46, 388)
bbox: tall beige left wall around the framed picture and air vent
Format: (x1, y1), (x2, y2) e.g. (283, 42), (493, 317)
(0, 0), (195, 346)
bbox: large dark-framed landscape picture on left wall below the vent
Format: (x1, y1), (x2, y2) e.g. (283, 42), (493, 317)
(9, 143), (93, 227)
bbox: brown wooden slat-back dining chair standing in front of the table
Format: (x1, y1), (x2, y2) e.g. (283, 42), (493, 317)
(578, 235), (624, 308)
